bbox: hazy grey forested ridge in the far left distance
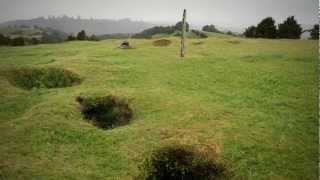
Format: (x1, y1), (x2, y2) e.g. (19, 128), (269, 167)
(0, 16), (152, 35)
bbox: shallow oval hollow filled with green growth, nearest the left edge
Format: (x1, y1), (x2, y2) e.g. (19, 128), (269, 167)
(8, 68), (81, 90)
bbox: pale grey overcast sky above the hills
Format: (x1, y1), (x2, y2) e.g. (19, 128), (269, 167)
(0, 0), (319, 27)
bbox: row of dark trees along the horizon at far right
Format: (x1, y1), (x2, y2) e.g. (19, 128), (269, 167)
(243, 16), (319, 39)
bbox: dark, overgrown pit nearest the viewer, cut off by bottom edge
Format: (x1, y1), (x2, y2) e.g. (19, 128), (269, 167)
(140, 145), (227, 180)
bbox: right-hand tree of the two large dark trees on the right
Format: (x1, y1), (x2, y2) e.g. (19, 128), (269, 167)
(278, 16), (302, 39)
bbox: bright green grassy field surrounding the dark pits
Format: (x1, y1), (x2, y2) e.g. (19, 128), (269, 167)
(0, 36), (318, 180)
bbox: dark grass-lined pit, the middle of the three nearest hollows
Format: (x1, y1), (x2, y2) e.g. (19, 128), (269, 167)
(76, 95), (133, 129)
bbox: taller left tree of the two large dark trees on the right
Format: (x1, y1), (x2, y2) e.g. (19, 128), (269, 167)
(256, 17), (277, 39)
